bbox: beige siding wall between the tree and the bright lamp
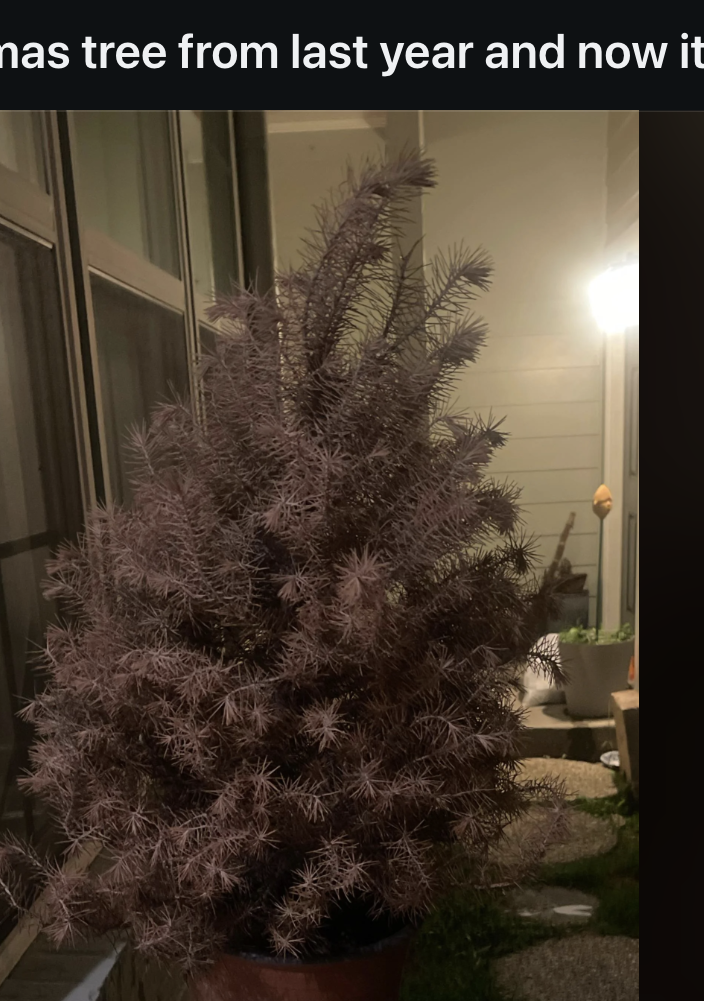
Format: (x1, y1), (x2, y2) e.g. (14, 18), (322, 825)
(424, 111), (607, 617)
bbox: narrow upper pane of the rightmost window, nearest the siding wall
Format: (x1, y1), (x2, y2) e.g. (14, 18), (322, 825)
(181, 111), (238, 304)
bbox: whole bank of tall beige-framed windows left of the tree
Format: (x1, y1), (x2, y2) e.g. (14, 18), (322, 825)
(0, 111), (253, 952)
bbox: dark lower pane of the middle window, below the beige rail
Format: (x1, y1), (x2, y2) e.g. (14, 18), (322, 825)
(90, 275), (188, 503)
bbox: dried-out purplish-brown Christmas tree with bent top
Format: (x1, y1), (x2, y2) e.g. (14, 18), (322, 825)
(3, 155), (555, 969)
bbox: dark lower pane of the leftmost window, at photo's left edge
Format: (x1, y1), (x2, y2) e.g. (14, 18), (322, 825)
(0, 228), (81, 884)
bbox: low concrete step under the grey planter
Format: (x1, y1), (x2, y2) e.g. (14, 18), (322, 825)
(521, 704), (616, 762)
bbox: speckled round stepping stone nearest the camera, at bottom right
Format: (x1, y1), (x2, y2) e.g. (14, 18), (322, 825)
(495, 935), (639, 1001)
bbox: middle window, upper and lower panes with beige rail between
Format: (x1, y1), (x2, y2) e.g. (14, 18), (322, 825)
(73, 111), (189, 503)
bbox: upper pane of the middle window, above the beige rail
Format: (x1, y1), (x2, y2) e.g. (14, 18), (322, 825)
(74, 111), (180, 277)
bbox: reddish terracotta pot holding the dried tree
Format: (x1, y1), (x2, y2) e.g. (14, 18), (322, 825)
(190, 931), (412, 1001)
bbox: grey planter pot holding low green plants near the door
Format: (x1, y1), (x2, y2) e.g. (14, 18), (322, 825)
(560, 640), (633, 718)
